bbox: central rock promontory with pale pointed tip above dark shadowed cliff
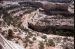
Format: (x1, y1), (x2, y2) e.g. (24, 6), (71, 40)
(28, 14), (74, 31)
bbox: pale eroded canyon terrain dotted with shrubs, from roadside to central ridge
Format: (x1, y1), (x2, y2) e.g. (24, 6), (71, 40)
(0, 0), (74, 49)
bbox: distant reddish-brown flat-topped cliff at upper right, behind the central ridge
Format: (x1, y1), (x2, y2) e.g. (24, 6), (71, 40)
(40, 1), (69, 11)
